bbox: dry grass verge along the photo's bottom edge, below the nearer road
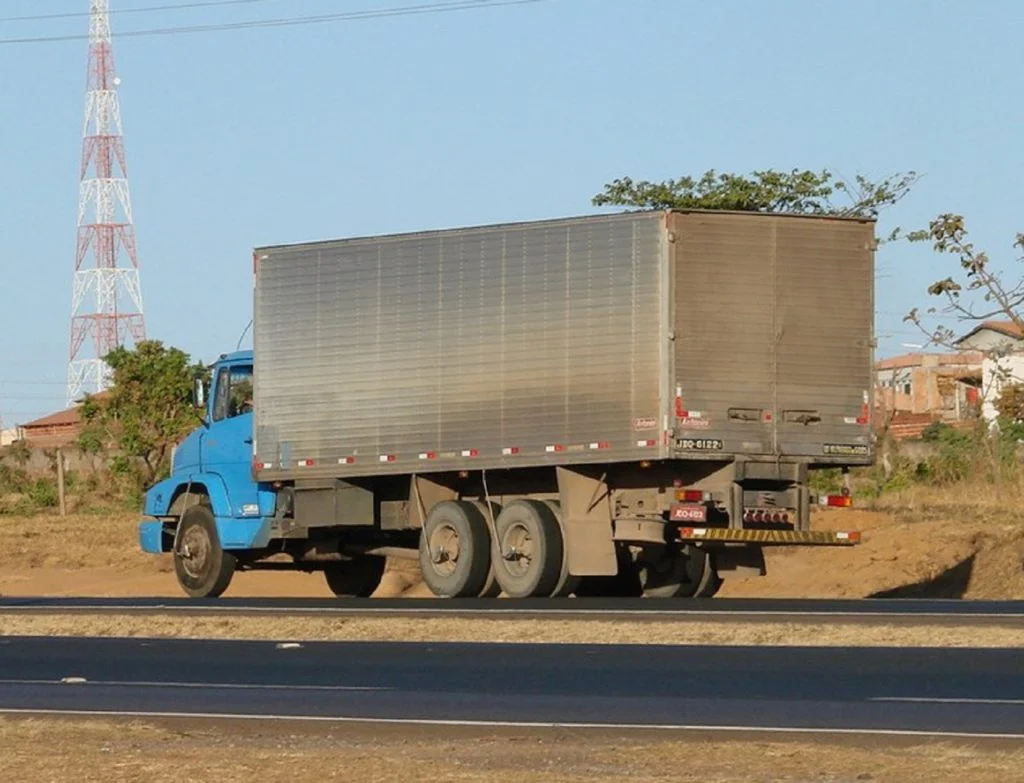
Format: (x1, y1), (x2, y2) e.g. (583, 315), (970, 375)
(0, 719), (1024, 783)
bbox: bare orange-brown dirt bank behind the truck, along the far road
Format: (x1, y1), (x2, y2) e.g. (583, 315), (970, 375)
(0, 501), (1024, 599)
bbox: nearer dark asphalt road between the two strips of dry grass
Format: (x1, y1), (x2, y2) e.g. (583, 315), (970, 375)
(0, 637), (1024, 742)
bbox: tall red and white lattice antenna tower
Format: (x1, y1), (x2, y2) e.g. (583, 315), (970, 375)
(68, 0), (145, 405)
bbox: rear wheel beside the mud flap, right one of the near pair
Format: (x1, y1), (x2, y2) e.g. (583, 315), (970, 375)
(495, 499), (564, 598)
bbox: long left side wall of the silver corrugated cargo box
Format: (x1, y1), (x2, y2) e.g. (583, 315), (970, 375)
(253, 212), (671, 480)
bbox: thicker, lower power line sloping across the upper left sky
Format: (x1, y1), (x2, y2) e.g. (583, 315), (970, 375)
(0, 0), (547, 46)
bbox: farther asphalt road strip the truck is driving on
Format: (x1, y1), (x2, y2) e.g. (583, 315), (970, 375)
(0, 596), (1024, 627)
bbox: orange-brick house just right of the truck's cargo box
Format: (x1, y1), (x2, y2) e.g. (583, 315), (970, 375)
(874, 351), (984, 438)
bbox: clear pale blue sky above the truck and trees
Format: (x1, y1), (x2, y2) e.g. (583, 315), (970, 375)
(0, 0), (1024, 426)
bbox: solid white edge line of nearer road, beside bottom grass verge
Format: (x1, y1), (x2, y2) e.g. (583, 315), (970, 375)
(0, 707), (1024, 740)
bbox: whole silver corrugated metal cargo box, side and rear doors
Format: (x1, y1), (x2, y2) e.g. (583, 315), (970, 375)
(253, 207), (873, 480)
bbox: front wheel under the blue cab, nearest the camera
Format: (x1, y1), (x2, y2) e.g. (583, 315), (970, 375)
(173, 506), (236, 598)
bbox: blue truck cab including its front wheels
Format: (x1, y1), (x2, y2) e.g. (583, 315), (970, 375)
(138, 351), (385, 598)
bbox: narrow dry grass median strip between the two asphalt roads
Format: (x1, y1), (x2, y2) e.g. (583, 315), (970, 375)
(0, 613), (1024, 648)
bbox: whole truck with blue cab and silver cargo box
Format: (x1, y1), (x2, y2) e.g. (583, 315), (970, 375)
(138, 210), (876, 599)
